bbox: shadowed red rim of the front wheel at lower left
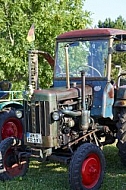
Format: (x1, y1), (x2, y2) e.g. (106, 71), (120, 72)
(4, 149), (26, 177)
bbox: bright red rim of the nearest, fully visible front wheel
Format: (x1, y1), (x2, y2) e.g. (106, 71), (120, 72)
(81, 154), (101, 188)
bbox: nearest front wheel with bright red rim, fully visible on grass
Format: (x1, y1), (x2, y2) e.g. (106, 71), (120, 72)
(69, 143), (105, 190)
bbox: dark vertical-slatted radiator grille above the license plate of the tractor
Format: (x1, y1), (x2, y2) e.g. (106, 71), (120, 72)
(24, 101), (50, 136)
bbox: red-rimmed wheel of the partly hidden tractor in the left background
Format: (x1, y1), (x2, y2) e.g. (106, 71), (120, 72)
(0, 108), (24, 141)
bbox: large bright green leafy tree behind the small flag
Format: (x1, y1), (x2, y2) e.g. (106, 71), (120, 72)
(0, 0), (91, 90)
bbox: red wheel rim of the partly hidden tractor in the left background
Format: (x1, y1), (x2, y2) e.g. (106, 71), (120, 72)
(1, 118), (23, 140)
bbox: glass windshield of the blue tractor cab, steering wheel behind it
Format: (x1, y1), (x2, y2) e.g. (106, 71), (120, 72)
(54, 39), (108, 78)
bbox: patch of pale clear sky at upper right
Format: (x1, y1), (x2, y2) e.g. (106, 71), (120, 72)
(84, 0), (126, 25)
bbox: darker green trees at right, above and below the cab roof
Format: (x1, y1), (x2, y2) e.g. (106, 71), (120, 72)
(98, 16), (126, 80)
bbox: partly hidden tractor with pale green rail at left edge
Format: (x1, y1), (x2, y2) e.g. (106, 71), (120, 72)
(0, 80), (23, 142)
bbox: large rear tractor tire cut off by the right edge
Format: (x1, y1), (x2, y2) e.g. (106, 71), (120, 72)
(117, 109), (126, 166)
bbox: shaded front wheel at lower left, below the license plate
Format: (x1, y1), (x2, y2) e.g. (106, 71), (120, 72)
(0, 137), (29, 181)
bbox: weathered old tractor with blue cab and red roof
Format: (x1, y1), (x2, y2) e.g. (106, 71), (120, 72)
(0, 28), (126, 190)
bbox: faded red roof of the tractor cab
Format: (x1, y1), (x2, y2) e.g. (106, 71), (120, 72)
(57, 28), (126, 40)
